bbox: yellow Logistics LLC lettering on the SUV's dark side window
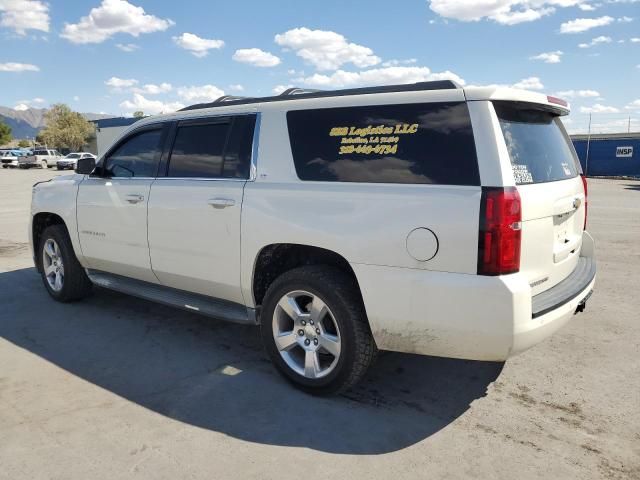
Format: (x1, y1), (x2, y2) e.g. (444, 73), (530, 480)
(329, 123), (418, 155)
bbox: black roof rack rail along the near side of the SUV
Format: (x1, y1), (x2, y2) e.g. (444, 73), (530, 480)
(180, 80), (462, 112)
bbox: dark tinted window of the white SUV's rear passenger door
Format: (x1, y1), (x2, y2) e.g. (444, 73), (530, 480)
(168, 115), (255, 179)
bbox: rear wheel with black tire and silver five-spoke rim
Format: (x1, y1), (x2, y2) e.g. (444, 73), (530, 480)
(260, 265), (377, 395)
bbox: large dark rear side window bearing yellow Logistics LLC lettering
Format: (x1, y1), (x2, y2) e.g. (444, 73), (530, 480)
(287, 102), (480, 185)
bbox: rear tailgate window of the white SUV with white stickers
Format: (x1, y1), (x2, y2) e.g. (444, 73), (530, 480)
(494, 102), (580, 185)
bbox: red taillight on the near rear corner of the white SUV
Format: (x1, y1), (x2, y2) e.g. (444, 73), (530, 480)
(478, 187), (522, 275)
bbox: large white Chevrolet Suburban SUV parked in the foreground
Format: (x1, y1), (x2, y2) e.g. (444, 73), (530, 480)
(29, 81), (596, 393)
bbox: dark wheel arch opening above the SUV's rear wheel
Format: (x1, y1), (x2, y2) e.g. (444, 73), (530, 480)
(251, 243), (362, 306)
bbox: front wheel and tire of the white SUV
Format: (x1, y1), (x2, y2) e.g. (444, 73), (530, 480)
(36, 225), (92, 302)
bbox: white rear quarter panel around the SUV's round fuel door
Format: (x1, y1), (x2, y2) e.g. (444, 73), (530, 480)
(241, 99), (481, 306)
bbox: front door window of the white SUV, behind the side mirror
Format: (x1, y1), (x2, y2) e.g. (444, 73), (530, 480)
(105, 129), (162, 177)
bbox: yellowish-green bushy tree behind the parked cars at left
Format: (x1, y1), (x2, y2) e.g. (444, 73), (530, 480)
(39, 103), (94, 151)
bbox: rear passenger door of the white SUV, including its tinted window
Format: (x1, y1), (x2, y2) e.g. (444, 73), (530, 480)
(148, 114), (256, 303)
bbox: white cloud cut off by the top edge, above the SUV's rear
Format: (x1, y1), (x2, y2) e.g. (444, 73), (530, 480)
(429, 0), (585, 25)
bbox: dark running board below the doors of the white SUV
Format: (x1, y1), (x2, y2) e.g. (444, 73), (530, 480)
(87, 270), (258, 325)
